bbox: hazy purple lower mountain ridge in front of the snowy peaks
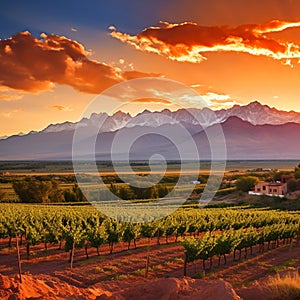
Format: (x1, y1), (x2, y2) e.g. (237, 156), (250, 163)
(0, 116), (300, 160)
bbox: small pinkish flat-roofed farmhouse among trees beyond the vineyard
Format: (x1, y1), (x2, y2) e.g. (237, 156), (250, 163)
(249, 181), (287, 197)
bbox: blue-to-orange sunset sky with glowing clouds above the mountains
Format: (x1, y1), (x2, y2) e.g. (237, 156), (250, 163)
(0, 0), (300, 137)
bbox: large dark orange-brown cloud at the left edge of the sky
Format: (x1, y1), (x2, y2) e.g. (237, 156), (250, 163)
(0, 31), (153, 94)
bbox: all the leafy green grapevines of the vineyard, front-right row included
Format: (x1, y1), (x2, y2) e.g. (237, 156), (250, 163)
(0, 204), (300, 278)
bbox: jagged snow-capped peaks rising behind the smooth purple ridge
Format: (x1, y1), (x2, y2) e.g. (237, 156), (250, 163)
(0, 101), (300, 139)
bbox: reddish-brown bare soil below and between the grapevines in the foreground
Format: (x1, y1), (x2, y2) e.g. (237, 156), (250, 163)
(0, 239), (300, 300)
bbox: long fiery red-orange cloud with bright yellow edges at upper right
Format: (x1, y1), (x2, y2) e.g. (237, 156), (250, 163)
(110, 20), (300, 65)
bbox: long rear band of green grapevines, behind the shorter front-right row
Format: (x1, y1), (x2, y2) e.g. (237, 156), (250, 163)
(0, 204), (299, 258)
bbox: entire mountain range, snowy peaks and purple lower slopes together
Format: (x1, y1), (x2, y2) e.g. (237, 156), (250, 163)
(0, 101), (300, 160)
